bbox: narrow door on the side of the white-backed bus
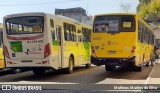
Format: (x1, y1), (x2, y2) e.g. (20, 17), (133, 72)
(56, 26), (63, 67)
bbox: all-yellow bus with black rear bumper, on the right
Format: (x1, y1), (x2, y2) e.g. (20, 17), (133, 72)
(91, 13), (154, 71)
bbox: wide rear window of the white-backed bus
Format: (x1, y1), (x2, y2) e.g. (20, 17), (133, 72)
(5, 16), (44, 35)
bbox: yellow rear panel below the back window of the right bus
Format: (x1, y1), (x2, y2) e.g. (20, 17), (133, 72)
(92, 32), (136, 58)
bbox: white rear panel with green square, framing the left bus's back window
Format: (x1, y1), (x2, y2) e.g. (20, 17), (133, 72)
(4, 13), (59, 69)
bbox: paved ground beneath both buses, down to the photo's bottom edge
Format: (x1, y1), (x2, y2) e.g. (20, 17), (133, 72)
(0, 66), (152, 93)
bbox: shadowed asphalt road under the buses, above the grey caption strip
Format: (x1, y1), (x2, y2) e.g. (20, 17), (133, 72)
(0, 66), (152, 84)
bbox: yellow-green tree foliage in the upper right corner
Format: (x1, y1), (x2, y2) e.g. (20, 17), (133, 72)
(137, 0), (160, 24)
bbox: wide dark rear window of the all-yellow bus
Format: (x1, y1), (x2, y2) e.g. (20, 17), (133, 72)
(93, 15), (135, 33)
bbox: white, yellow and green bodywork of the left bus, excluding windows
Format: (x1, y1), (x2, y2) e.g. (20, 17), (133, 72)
(4, 13), (91, 69)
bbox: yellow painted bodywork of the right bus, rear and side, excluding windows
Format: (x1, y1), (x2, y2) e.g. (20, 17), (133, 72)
(91, 13), (154, 66)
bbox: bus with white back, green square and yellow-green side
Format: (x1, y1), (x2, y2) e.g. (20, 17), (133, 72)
(3, 13), (91, 75)
